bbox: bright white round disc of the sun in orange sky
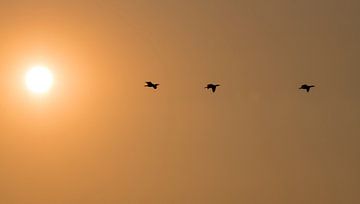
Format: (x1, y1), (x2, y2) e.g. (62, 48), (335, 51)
(25, 66), (54, 94)
